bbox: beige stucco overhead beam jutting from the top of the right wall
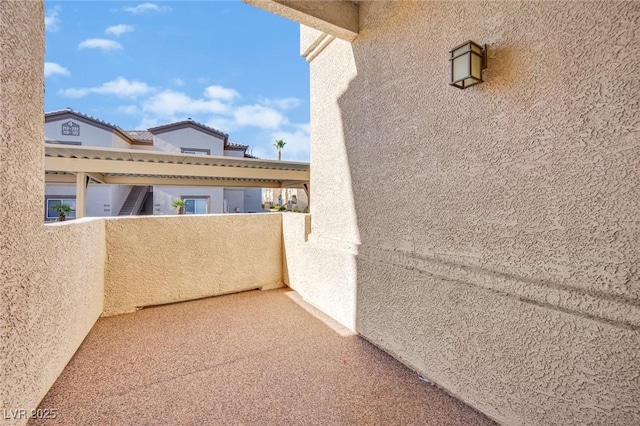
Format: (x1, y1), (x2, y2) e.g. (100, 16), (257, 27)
(242, 0), (360, 41)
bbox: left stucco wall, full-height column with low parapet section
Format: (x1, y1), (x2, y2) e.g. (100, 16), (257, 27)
(0, 1), (104, 423)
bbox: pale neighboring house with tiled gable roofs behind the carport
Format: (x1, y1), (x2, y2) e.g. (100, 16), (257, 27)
(44, 109), (262, 220)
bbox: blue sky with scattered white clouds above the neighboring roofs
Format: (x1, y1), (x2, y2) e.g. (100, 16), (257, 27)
(45, 0), (309, 161)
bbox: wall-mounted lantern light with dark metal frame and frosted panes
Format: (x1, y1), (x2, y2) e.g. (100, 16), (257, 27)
(449, 40), (487, 89)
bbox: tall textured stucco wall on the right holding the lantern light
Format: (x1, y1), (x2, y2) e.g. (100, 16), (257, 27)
(298, 1), (640, 424)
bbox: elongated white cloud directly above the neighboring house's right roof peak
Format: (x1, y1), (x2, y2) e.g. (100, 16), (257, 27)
(142, 89), (229, 119)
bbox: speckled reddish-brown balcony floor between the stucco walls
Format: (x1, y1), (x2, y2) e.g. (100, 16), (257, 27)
(30, 289), (493, 425)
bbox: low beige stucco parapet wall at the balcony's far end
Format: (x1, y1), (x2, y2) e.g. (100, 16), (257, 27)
(103, 213), (283, 315)
